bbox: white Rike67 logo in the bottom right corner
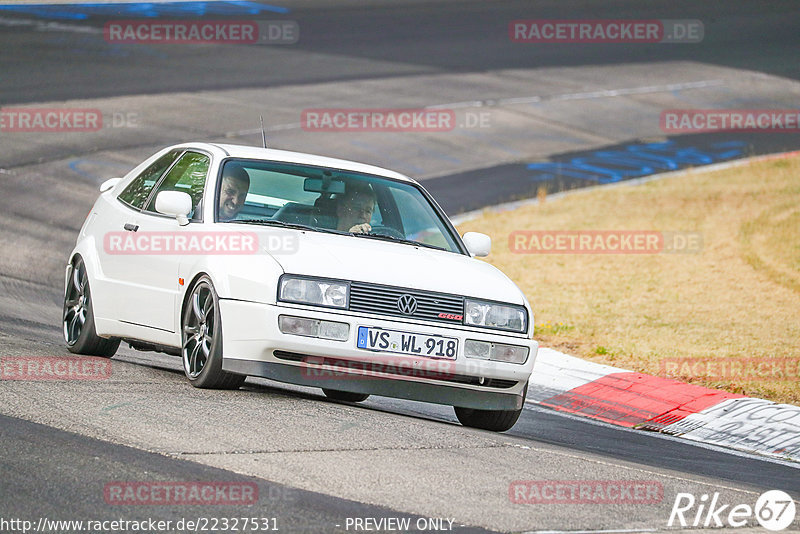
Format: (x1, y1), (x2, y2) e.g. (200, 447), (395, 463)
(667, 490), (796, 532)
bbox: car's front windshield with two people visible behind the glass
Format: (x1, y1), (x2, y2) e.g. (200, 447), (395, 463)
(217, 159), (462, 253)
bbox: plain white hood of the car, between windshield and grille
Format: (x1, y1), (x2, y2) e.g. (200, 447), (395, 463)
(260, 229), (525, 304)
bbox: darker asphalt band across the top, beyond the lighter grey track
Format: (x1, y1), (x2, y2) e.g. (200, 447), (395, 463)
(0, 0), (800, 104)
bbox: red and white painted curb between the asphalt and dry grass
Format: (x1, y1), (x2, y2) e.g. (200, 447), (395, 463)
(527, 348), (800, 461)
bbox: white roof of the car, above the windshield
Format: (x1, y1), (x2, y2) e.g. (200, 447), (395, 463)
(175, 143), (415, 182)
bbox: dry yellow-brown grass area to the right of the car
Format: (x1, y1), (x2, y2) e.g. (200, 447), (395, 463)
(459, 157), (800, 404)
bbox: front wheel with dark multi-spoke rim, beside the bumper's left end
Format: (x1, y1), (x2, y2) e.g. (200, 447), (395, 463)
(181, 276), (247, 389)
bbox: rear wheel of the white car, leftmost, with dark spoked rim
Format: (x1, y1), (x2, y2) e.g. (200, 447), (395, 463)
(61, 256), (120, 358)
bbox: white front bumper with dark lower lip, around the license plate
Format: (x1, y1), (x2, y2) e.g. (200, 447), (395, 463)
(220, 299), (538, 410)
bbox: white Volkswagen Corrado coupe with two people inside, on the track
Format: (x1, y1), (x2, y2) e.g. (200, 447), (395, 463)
(63, 143), (538, 431)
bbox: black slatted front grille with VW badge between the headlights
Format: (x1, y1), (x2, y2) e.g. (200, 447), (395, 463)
(350, 282), (464, 324)
